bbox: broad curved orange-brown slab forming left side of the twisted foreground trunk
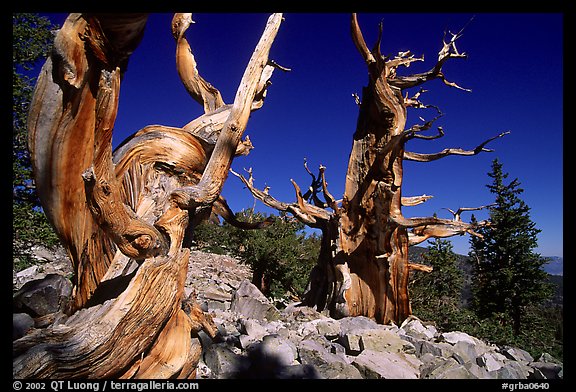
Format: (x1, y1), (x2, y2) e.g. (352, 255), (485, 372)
(28, 14), (147, 308)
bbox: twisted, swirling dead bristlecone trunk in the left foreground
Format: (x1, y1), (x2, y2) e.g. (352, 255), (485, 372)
(13, 13), (282, 379)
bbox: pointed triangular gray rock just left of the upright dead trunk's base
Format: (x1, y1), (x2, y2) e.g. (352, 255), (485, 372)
(230, 279), (280, 321)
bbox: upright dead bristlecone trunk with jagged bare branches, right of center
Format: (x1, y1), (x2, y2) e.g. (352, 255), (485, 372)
(235, 15), (507, 324)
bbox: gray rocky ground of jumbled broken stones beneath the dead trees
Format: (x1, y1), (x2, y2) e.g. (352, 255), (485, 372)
(13, 248), (563, 379)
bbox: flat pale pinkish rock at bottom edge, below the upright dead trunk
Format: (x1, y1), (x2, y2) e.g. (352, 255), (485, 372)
(352, 350), (422, 379)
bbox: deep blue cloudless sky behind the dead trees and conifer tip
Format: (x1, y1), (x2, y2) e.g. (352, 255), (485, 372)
(38, 13), (563, 256)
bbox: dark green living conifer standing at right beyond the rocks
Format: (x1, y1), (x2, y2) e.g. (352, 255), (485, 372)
(470, 159), (552, 335)
